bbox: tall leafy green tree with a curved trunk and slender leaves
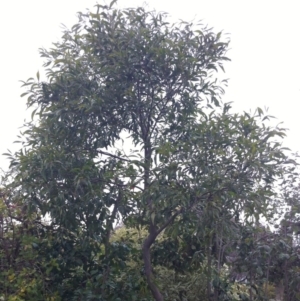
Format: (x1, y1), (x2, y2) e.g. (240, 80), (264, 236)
(11, 3), (292, 300)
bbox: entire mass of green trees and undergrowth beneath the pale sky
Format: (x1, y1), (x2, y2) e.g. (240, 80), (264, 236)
(0, 1), (300, 301)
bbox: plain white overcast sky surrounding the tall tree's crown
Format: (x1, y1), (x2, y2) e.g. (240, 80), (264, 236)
(0, 0), (300, 168)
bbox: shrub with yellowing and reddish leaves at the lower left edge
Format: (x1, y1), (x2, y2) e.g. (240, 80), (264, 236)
(0, 177), (61, 301)
